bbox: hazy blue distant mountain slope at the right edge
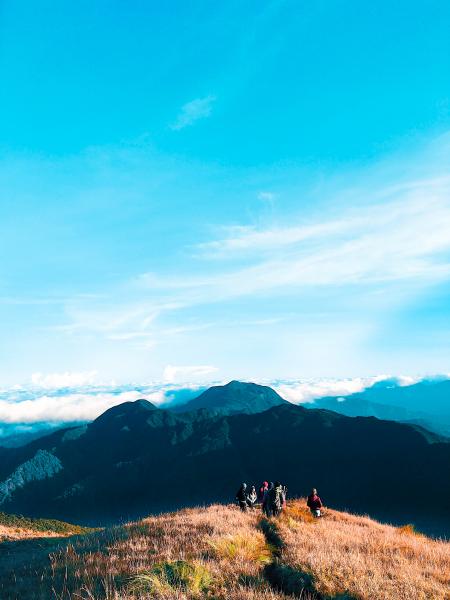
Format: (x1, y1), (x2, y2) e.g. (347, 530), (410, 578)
(305, 380), (450, 436)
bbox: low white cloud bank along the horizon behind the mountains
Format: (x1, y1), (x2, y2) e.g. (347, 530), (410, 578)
(0, 373), (448, 437)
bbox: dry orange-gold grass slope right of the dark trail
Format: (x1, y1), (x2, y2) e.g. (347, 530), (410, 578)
(279, 502), (450, 600)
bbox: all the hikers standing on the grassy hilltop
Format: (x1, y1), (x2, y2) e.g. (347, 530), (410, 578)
(236, 481), (323, 517)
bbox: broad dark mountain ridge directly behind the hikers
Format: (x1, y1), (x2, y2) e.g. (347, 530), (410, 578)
(0, 386), (450, 523)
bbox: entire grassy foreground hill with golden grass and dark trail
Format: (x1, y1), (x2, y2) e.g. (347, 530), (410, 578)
(0, 500), (450, 600)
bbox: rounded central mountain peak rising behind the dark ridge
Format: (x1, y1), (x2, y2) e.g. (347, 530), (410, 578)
(172, 381), (287, 415)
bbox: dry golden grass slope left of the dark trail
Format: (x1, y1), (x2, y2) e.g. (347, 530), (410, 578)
(0, 506), (285, 600)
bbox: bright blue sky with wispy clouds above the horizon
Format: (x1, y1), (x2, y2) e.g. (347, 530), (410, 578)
(0, 0), (450, 385)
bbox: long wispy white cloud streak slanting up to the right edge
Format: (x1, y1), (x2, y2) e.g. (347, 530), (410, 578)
(59, 164), (450, 348)
